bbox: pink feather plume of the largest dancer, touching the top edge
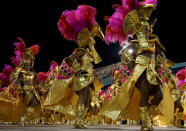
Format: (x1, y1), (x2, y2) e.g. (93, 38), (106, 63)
(105, 0), (157, 45)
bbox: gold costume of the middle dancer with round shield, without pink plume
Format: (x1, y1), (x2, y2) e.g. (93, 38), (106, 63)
(43, 19), (104, 128)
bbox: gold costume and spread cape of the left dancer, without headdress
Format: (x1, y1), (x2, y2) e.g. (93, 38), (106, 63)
(0, 62), (39, 123)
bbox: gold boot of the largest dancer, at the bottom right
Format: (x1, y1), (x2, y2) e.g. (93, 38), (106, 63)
(139, 106), (153, 131)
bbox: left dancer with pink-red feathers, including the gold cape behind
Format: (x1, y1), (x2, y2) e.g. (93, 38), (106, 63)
(1, 38), (39, 125)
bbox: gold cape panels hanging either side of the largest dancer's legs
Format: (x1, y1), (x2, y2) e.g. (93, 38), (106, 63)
(100, 64), (174, 122)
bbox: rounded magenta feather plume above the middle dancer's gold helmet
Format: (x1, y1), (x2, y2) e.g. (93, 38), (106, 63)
(58, 5), (97, 41)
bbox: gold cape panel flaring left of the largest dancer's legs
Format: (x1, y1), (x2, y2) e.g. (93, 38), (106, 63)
(100, 64), (147, 120)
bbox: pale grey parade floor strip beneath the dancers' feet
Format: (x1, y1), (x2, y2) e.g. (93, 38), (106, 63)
(0, 125), (186, 131)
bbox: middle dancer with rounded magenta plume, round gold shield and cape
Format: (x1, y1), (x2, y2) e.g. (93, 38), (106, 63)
(44, 5), (104, 128)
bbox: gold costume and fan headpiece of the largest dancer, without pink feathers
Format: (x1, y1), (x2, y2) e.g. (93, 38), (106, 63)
(101, 5), (174, 130)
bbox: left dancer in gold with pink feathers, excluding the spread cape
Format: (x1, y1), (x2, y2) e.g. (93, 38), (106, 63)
(10, 38), (39, 126)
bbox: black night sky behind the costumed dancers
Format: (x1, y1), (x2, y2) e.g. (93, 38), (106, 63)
(0, 0), (186, 72)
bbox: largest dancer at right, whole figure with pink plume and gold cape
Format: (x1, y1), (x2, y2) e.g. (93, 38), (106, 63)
(102, 0), (173, 131)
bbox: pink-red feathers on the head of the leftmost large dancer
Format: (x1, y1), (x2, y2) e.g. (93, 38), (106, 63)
(10, 37), (39, 66)
